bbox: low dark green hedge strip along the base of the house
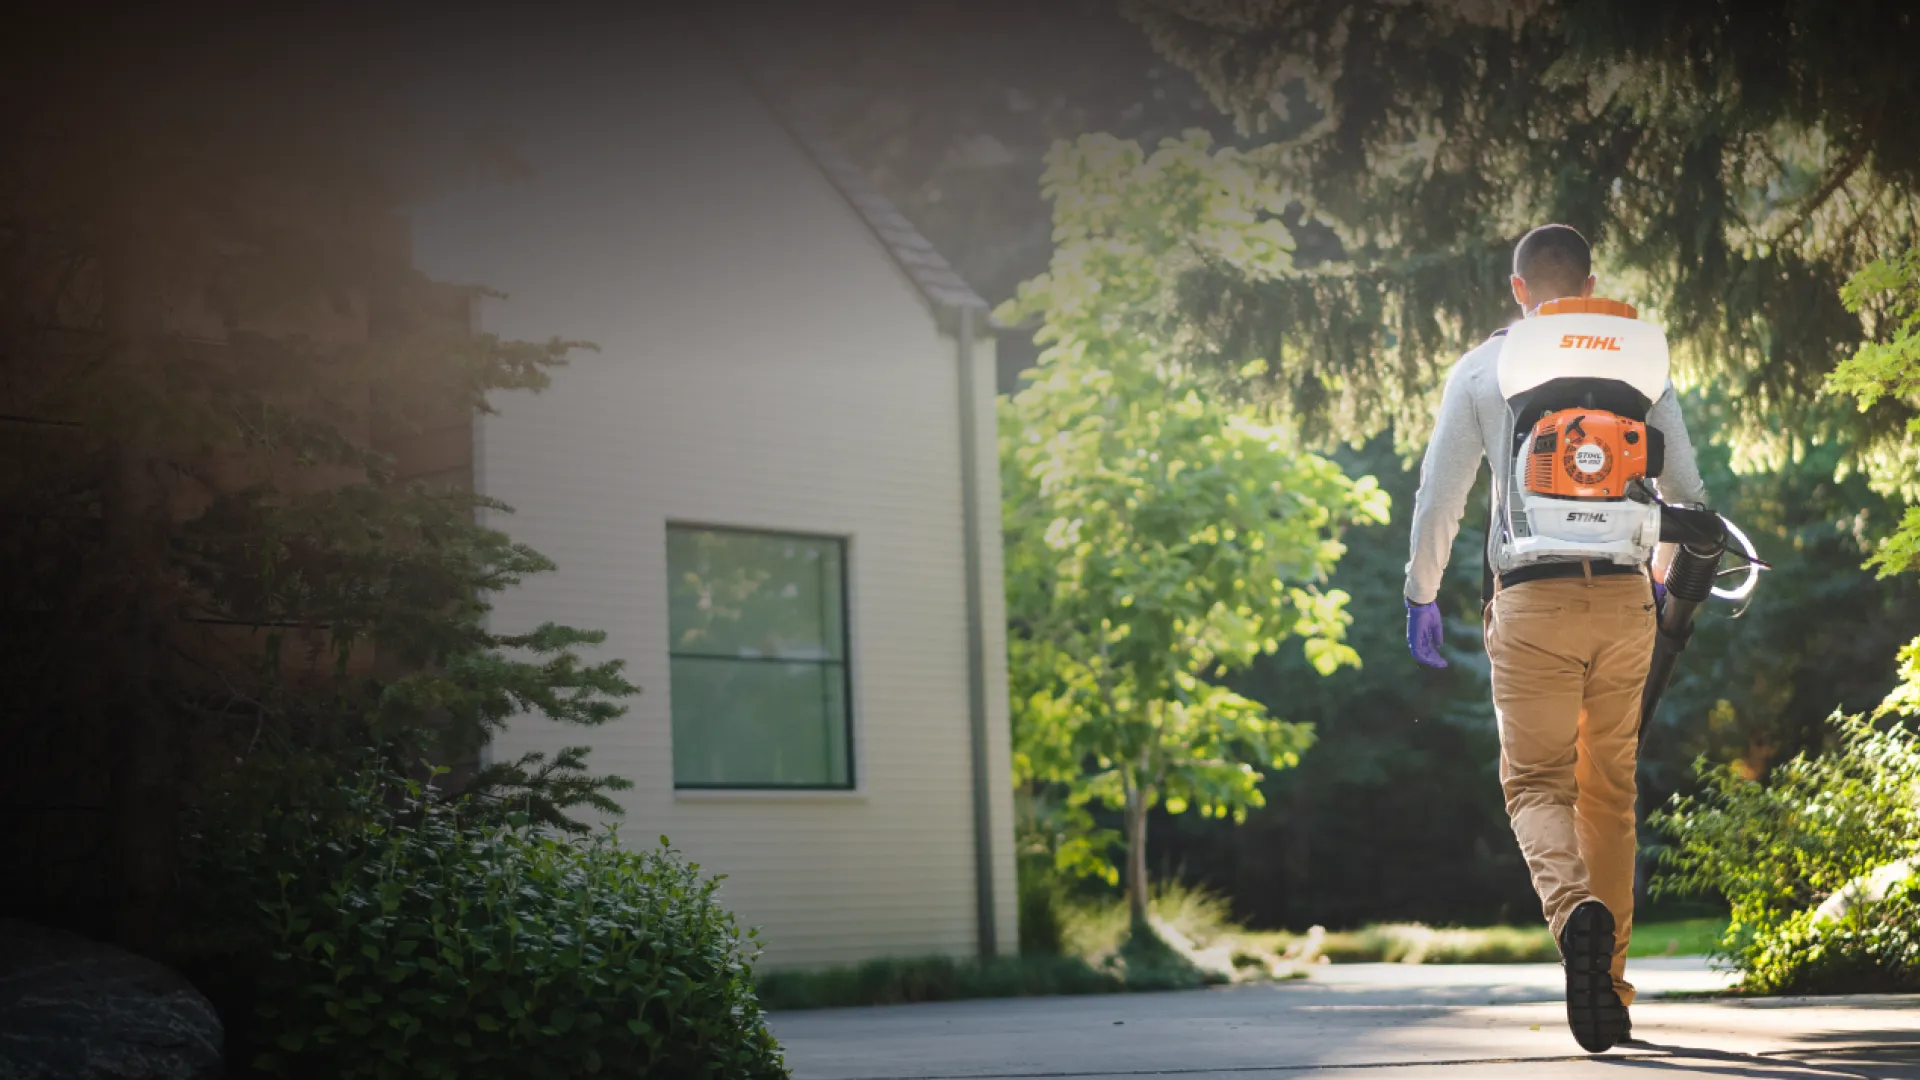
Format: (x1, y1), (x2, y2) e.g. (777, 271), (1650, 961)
(756, 957), (1127, 1009)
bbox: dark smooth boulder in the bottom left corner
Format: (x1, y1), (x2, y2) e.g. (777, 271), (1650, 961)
(0, 919), (221, 1080)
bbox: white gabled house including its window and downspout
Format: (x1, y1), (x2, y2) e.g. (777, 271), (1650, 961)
(415, 13), (1016, 967)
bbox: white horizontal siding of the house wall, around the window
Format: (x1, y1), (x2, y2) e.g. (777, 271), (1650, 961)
(415, 16), (1016, 967)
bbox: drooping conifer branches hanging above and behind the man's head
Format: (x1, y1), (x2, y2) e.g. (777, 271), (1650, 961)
(1127, 0), (1920, 461)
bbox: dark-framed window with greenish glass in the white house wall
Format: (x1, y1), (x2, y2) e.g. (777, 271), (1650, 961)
(666, 527), (852, 788)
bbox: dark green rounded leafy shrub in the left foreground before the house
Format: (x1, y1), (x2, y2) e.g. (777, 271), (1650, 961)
(178, 771), (785, 1078)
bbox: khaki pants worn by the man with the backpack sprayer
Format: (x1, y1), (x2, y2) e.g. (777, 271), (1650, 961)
(1486, 575), (1653, 1003)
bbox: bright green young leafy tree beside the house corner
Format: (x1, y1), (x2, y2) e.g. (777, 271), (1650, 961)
(1000, 133), (1386, 924)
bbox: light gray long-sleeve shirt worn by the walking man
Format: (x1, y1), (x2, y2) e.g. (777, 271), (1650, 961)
(1405, 331), (1707, 603)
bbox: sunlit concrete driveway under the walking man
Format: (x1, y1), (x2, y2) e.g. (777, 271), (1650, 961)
(774, 959), (1920, 1080)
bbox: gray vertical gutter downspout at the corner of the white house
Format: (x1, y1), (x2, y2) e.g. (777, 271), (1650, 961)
(954, 306), (1000, 957)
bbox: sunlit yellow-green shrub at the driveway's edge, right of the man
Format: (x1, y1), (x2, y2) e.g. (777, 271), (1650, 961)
(1651, 717), (1920, 992)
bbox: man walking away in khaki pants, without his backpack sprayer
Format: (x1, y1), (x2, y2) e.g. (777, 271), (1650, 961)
(1405, 225), (1705, 1053)
